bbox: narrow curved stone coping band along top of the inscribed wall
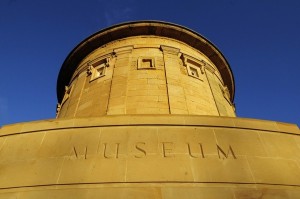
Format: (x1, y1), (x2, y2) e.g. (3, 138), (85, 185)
(0, 114), (300, 137)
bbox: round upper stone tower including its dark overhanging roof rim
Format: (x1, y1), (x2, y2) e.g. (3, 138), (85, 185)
(57, 22), (235, 118)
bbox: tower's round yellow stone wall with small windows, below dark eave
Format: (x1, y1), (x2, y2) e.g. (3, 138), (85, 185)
(57, 36), (235, 118)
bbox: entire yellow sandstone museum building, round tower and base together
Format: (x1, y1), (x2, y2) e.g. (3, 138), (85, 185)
(0, 21), (300, 199)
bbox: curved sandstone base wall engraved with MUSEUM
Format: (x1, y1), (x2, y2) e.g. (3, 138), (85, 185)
(0, 115), (300, 199)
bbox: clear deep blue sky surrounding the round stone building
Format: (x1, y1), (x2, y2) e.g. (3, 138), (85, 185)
(0, 0), (300, 126)
